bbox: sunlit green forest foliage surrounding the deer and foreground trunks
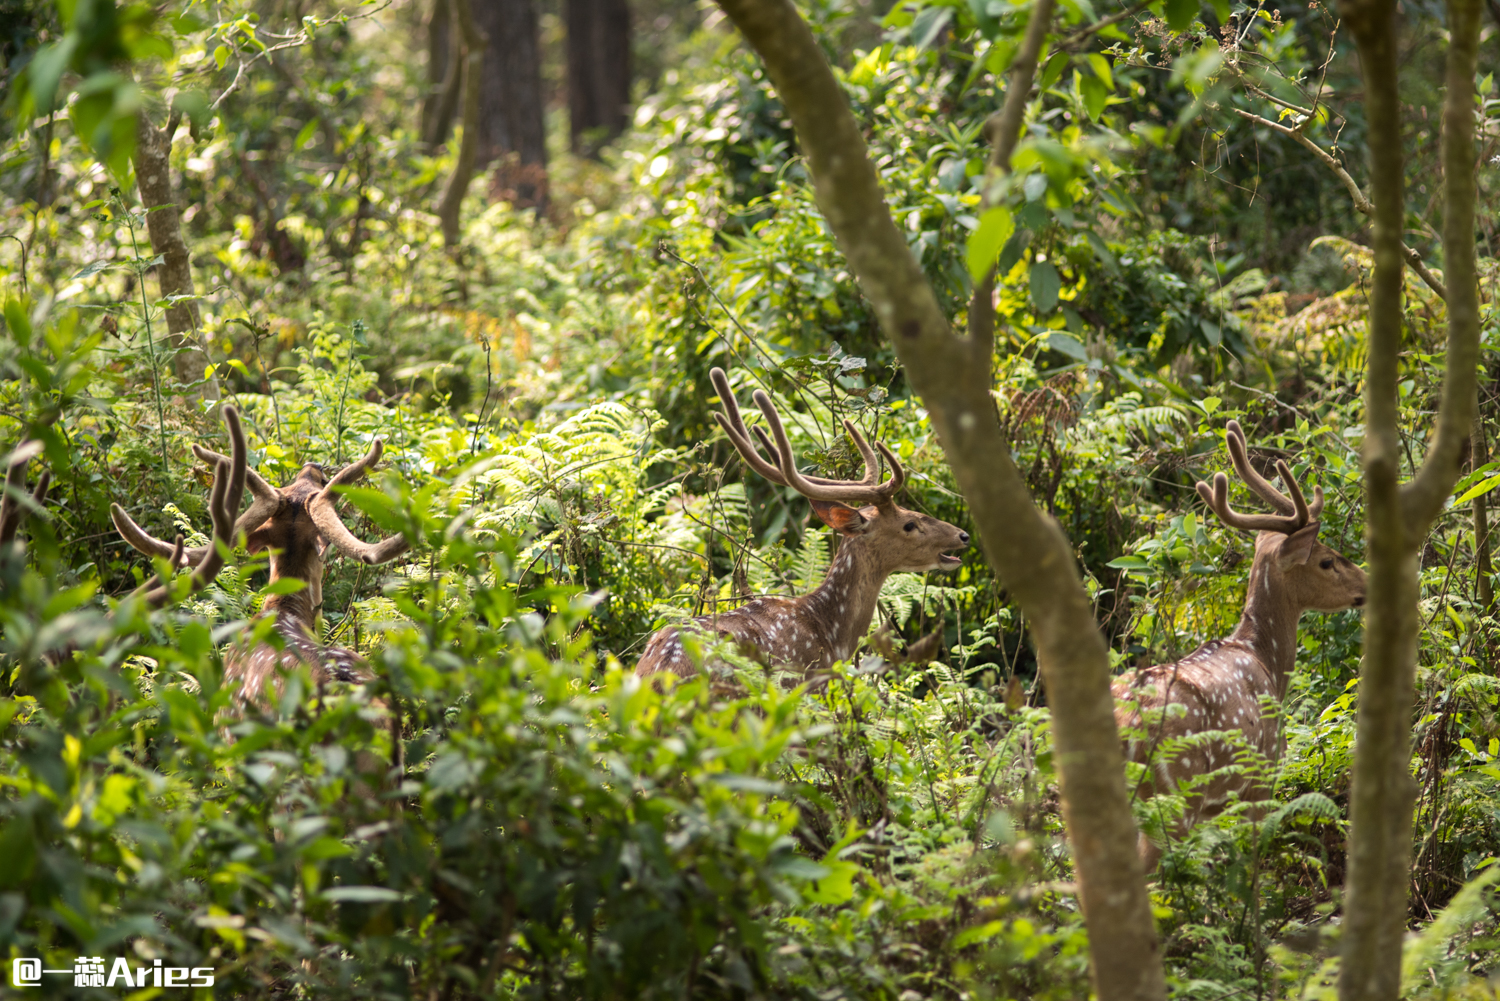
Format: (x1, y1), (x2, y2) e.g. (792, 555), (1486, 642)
(0, 0), (1500, 999)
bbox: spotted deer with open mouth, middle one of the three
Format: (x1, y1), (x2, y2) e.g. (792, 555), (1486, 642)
(636, 368), (969, 675)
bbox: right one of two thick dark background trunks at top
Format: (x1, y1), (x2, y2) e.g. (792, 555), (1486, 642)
(563, 0), (630, 158)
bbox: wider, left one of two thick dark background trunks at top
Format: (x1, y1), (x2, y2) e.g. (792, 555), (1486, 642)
(474, 0), (548, 210)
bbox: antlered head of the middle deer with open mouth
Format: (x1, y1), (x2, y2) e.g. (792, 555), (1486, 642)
(708, 368), (969, 575)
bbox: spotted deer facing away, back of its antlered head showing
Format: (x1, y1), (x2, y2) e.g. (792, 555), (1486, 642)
(110, 407), (408, 707)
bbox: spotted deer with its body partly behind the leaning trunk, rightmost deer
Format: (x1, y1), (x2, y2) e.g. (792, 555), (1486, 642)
(1113, 420), (1365, 870)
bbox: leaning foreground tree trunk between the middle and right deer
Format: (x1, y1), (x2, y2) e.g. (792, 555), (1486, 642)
(708, 0), (1166, 1001)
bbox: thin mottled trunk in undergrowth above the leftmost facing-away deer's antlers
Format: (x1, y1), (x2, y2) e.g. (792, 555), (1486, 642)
(134, 111), (219, 399)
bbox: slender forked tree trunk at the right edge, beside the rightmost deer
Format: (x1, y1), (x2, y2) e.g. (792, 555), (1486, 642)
(1338, 0), (1481, 1001)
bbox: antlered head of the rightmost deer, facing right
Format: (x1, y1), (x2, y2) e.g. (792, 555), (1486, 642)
(1197, 420), (1365, 612)
